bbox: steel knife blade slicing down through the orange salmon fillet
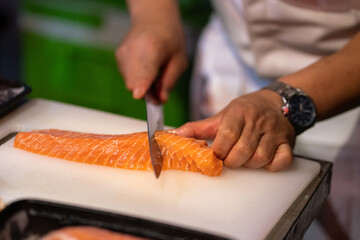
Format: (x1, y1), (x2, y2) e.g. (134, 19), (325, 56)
(145, 91), (164, 178)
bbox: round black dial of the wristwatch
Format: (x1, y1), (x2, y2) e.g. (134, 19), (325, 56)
(289, 95), (316, 128)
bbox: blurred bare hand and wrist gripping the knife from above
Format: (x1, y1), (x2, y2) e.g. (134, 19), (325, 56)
(116, 0), (187, 102)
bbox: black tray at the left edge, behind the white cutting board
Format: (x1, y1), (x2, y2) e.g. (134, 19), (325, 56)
(0, 78), (31, 117)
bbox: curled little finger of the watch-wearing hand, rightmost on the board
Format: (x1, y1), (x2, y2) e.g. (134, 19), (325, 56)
(265, 142), (293, 172)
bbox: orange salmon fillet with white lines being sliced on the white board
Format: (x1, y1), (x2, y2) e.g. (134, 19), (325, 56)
(14, 129), (223, 176)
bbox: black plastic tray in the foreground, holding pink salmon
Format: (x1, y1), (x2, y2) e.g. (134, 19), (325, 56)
(0, 200), (225, 240)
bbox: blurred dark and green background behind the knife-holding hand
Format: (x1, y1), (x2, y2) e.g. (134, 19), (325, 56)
(0, 0), (211, 126)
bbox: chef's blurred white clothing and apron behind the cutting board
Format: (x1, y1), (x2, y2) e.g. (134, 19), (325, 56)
(191, 0), (360, 238)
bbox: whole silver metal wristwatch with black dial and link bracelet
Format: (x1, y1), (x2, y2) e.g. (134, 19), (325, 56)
(264, 81), (316, 135)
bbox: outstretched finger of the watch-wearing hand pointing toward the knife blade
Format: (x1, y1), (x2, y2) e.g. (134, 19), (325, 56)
(171, 116), (220, 139)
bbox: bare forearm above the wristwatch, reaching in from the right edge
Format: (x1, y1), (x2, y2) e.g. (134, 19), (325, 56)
(279, 33), (360, 120)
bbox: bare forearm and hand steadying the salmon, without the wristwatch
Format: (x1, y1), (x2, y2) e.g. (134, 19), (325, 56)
(174, 34), (360, 171)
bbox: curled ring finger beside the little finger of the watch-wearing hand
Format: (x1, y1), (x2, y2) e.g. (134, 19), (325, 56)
(243, 134), (277, 168)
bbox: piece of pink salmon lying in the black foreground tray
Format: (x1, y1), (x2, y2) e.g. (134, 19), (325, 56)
(41, 226), (145, 240)
